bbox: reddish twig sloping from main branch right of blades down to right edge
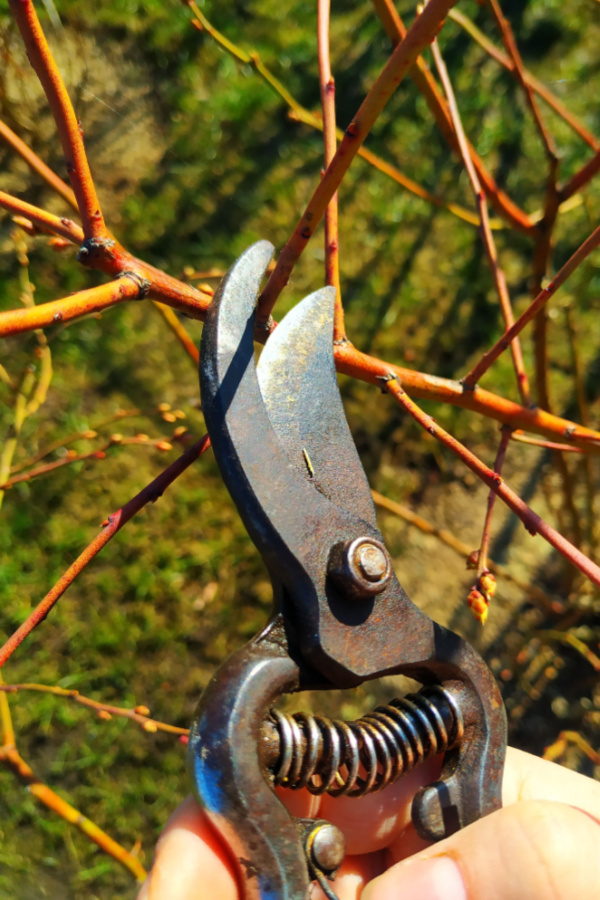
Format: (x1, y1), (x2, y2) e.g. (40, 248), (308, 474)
(385, 375), (600, 587)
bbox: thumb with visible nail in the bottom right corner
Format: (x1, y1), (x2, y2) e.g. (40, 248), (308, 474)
(362, 800), (600, 900)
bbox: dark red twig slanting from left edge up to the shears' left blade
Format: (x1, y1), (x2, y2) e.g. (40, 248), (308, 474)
(0, 435), (210, 667)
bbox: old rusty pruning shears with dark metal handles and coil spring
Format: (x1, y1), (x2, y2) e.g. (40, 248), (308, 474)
(188, 241), (506, 900)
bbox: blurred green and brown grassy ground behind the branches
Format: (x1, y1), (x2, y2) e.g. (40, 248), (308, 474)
(0, 0), (600, 900)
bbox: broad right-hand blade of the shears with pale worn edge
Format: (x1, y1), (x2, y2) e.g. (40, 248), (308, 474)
(256, 287), (377, 527)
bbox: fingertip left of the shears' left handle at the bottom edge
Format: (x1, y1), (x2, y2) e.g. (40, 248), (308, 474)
(138, 797), (238, 900)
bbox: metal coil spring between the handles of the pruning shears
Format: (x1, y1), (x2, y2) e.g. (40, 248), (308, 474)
(262, 685), (464, 797)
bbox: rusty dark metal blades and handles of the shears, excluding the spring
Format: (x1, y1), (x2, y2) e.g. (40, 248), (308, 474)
(189, 241), (506, 900)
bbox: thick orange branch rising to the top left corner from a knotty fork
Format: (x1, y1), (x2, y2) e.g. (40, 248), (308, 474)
(10, 0), (110, 241)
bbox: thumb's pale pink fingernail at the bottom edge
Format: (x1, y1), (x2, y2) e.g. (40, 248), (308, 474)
(362, 856), (467, 900)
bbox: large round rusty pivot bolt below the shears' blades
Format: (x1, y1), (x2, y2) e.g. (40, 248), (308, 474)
(327, 537), (392, 598)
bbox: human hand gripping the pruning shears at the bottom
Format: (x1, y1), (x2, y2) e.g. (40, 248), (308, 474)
(138, 749), (600, 900)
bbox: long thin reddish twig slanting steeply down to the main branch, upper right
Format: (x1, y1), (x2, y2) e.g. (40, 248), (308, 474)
(431, 40), (531, 406)
